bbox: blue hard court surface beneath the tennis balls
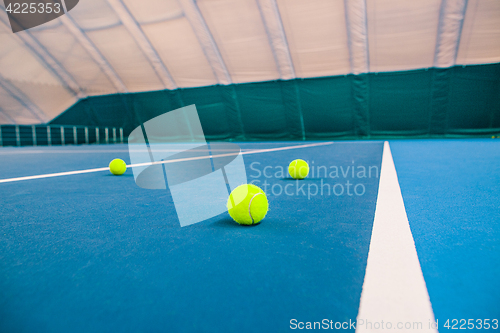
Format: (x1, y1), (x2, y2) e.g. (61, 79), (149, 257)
(0, 139), (500, 332)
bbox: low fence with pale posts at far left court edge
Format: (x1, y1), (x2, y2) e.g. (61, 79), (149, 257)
(0, 125), (124, 147)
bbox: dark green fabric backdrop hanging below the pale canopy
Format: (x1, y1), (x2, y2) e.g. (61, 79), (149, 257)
(51, 64), (500, 140)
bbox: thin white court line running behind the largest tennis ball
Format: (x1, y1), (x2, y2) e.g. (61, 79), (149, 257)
(0, 141), (333, 183)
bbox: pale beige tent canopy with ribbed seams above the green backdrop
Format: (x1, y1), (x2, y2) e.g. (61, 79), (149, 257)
(0, 0), (500, 124)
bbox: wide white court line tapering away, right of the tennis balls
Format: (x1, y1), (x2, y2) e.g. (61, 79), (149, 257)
(356, 141), (437, 333)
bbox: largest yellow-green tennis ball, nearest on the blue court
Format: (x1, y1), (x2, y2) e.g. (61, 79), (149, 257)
(227, 184), (269, 225)
